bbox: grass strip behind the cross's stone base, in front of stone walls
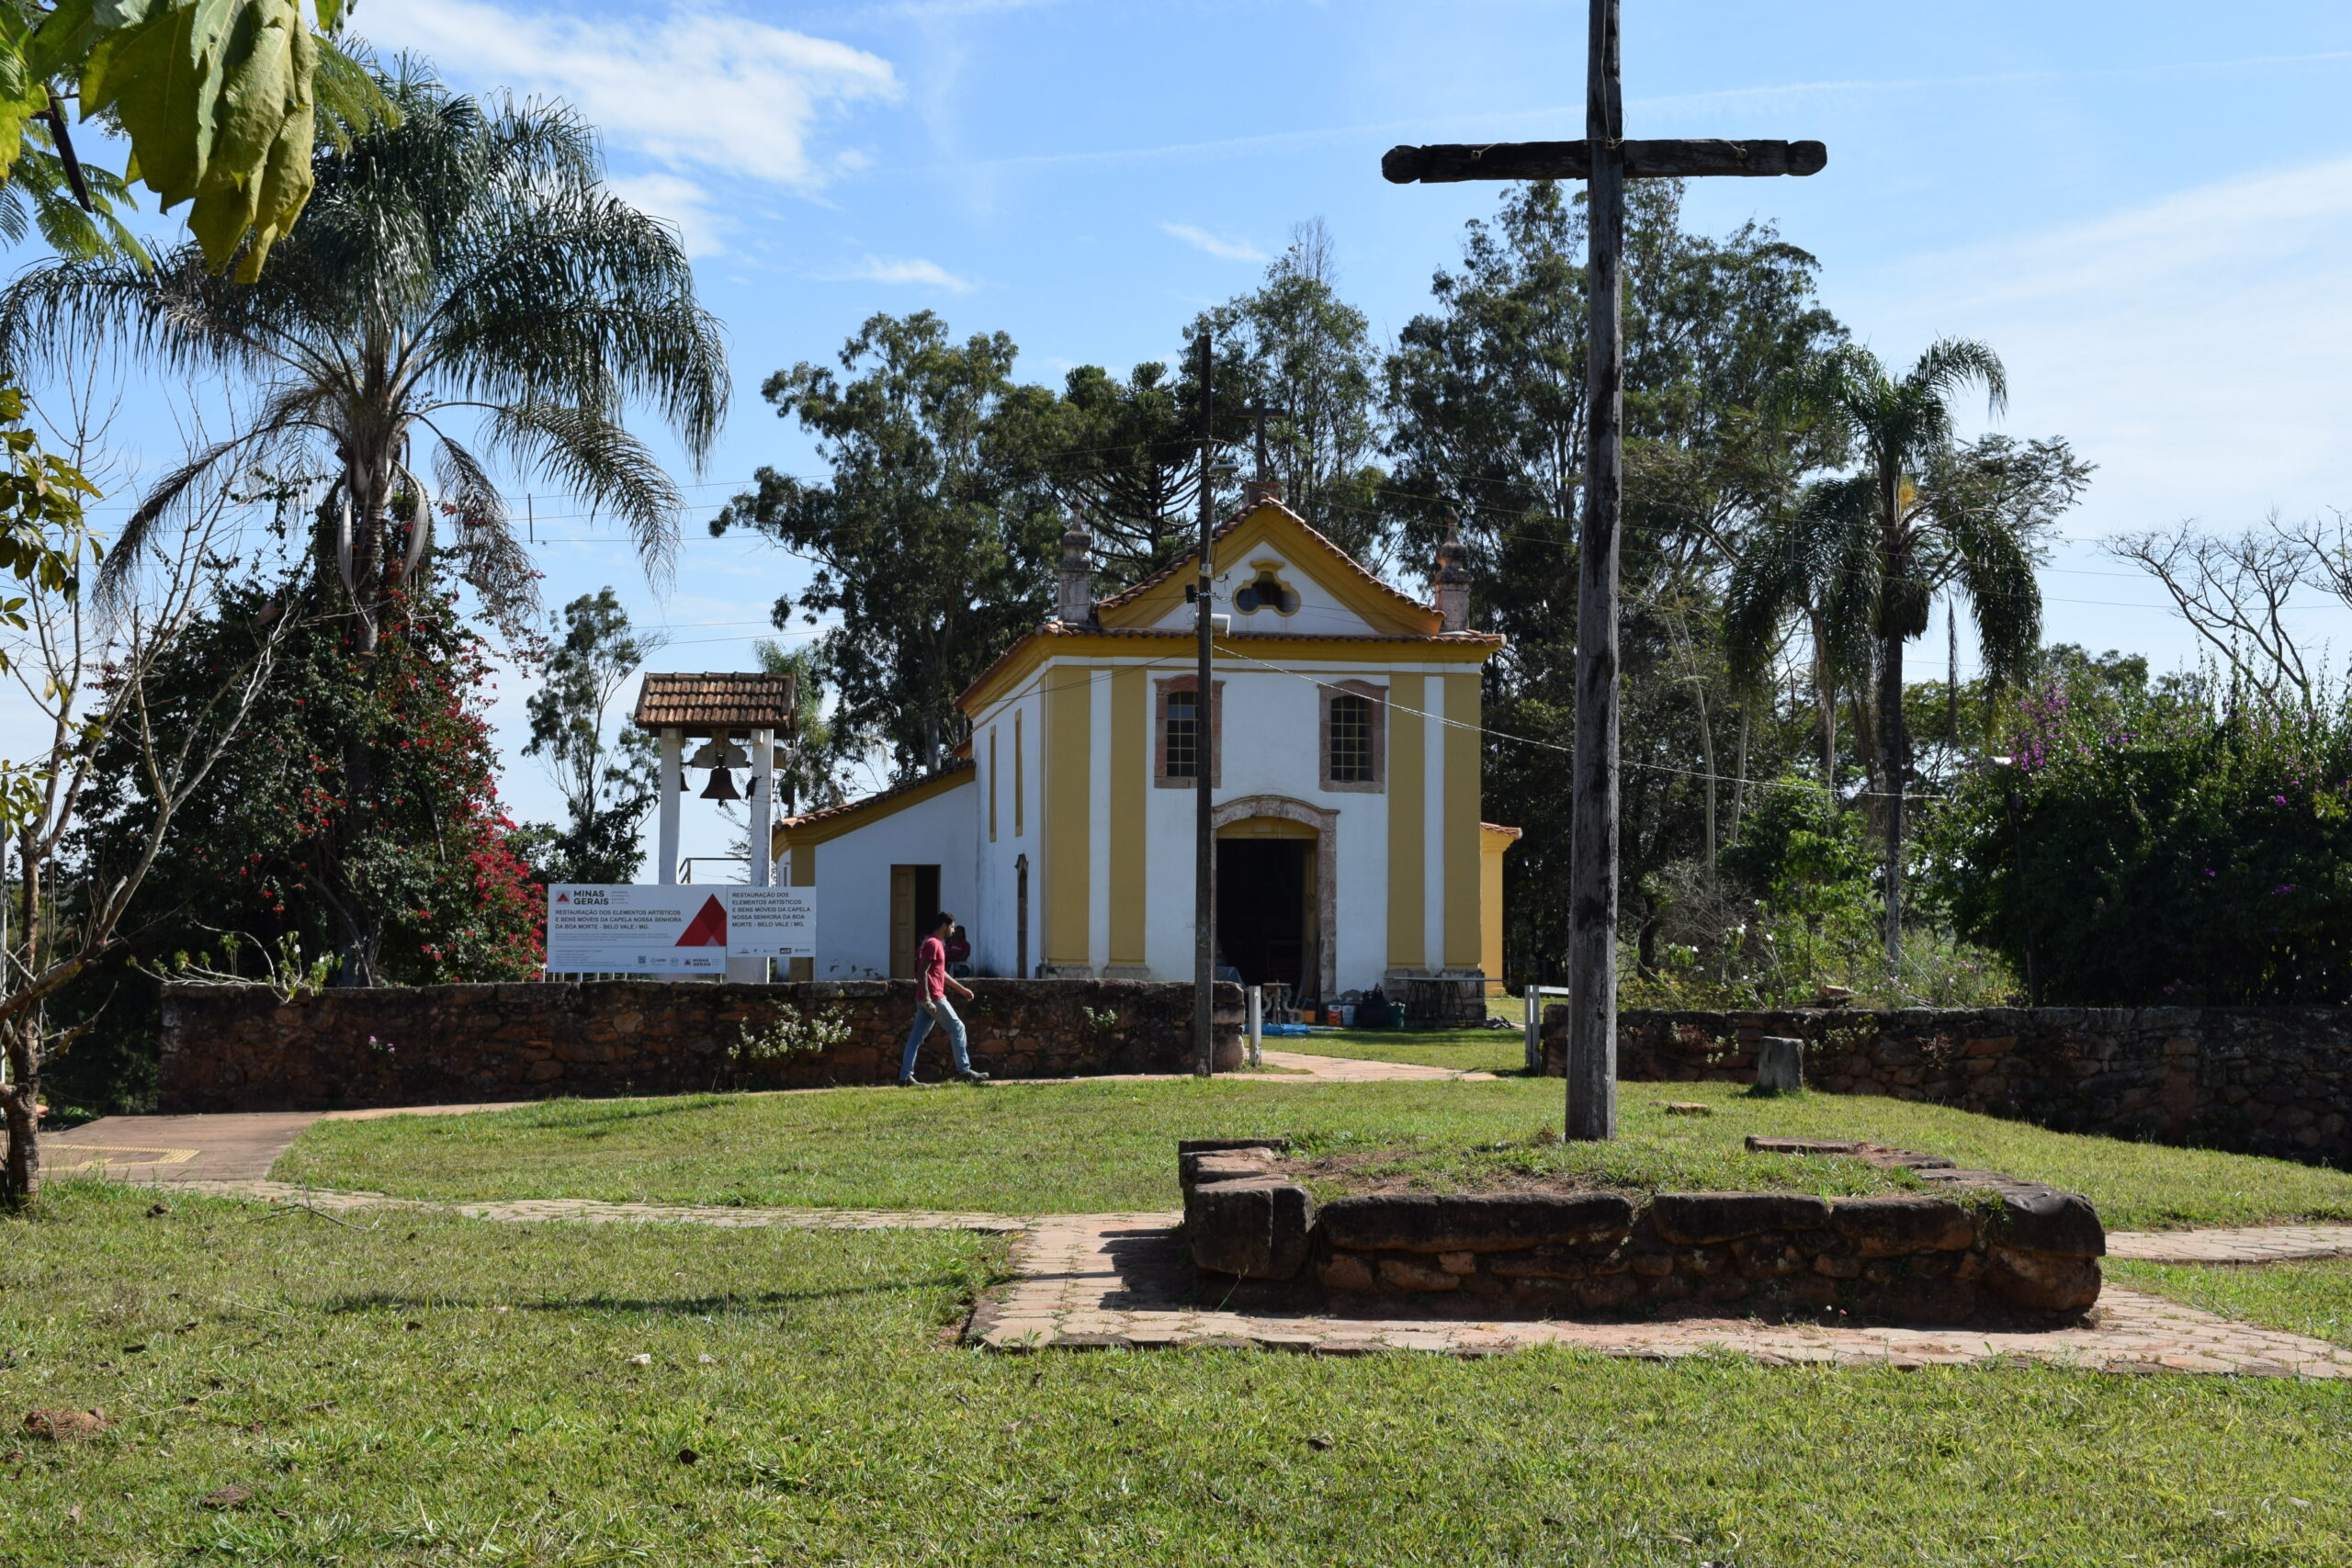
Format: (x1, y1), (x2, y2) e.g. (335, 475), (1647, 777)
(273, 1079), (2352, 1229)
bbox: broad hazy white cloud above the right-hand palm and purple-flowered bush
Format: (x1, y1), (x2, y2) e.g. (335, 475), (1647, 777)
(1832, 157), (2352, 665)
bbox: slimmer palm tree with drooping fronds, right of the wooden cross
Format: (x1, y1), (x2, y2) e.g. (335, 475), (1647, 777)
(1757, 339), (2041, 962)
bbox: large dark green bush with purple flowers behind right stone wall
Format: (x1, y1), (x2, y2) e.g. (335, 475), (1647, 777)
(1931, 682), (2352, 1006)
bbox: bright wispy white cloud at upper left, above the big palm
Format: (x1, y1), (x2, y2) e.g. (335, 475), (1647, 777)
(362, 0), (900, 249)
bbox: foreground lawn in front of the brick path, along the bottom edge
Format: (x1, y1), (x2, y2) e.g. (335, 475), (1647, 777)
(14, 1182), (2352, 1568)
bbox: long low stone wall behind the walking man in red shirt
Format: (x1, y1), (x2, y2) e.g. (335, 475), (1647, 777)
(158, 980), (1242, 1114)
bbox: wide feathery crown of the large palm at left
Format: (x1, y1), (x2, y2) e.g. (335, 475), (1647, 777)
(0, 63), (727, 651)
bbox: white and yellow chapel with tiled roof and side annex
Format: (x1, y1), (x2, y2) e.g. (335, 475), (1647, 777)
(774, 482), (1520, 1016)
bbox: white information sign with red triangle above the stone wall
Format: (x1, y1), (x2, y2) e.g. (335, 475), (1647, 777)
(548, 882), (816, 976)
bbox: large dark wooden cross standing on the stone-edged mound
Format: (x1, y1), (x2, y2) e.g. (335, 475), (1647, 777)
(1381, 0), (1830, 1138)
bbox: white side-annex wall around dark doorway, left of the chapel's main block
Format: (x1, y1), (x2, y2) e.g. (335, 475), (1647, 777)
(814, 781), (986, 980)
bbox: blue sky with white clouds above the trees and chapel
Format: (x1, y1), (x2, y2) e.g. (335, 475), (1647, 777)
(28, 0), (2352, 851)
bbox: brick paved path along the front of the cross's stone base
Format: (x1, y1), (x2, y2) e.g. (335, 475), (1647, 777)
(969, 1213), (2352, 1378)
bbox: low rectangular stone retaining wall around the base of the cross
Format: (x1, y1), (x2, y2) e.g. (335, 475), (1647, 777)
(1179, 1140), (2108, 1324)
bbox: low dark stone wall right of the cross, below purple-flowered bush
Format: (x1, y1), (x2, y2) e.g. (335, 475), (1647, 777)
(1545, 1006), (2352, 1161)
